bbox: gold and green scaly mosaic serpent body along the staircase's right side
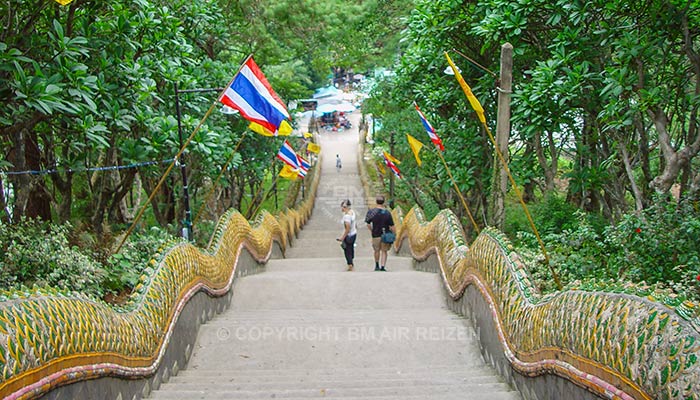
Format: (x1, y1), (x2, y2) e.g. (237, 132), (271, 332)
(393, 207), (700, 399)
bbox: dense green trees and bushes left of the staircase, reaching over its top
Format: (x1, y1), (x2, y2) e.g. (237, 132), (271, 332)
(0, 0), (410, 294)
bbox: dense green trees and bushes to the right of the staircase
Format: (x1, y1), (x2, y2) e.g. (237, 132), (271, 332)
(360, 0), (700, 299)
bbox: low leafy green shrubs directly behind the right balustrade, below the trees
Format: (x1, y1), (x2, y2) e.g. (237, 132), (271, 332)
(517, 200), (700, 301)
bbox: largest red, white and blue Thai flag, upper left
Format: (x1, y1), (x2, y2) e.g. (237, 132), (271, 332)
(219, 57), (289, 132)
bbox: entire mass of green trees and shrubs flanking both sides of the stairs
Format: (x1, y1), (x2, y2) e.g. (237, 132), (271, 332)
(0, 0), (700, 306)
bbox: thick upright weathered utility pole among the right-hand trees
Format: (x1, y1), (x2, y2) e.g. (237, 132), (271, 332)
(491, 43), (513, 230)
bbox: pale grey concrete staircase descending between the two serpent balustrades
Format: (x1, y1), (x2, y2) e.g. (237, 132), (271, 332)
(151, 108), (520, 400)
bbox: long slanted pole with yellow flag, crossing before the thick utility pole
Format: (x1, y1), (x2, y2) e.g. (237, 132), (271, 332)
(445, 52), (563, 290)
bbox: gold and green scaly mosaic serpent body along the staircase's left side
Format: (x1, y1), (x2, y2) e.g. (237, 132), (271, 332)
(0, 168), (320, 400)
